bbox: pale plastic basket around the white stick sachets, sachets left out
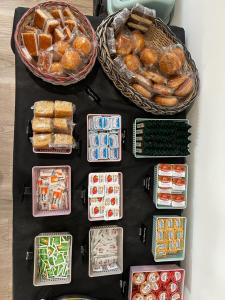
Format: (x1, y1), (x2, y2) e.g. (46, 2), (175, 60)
(88, 226), (123, 277)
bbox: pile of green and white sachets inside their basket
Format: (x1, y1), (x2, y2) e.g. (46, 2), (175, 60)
(36, 235), (72, 281)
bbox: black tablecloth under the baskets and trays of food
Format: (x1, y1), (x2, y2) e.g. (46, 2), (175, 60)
(12, 8), (185, 300)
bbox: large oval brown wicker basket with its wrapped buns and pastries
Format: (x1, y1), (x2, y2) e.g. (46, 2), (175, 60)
(96, 4), (199, 115)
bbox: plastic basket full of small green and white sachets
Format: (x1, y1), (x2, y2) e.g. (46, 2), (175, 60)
(33, 232), (72, 286)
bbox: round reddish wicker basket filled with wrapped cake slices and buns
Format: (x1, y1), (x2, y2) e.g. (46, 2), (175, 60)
(14, 1), (97, 85)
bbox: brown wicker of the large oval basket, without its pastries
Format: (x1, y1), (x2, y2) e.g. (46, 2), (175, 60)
(96, 12), (199, 115)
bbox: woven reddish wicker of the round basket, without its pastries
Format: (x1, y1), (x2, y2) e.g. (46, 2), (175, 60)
(14, 1), (97, 86)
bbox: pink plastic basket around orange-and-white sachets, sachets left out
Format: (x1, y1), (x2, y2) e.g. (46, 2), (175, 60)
(32, 166), (71, 217)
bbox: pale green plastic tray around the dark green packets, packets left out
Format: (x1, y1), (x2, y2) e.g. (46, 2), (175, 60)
(133, 118), (189, 158)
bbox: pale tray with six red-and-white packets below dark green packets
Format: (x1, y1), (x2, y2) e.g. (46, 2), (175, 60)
(153, 164), (188, 209)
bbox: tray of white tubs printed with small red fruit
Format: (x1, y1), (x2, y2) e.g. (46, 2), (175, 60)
(88, 172), (122, 221)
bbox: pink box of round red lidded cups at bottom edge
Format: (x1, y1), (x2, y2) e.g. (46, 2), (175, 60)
(128, 265), (185, 300)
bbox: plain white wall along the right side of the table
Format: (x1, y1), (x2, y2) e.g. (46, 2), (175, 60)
(173, 0), (225, 300)
